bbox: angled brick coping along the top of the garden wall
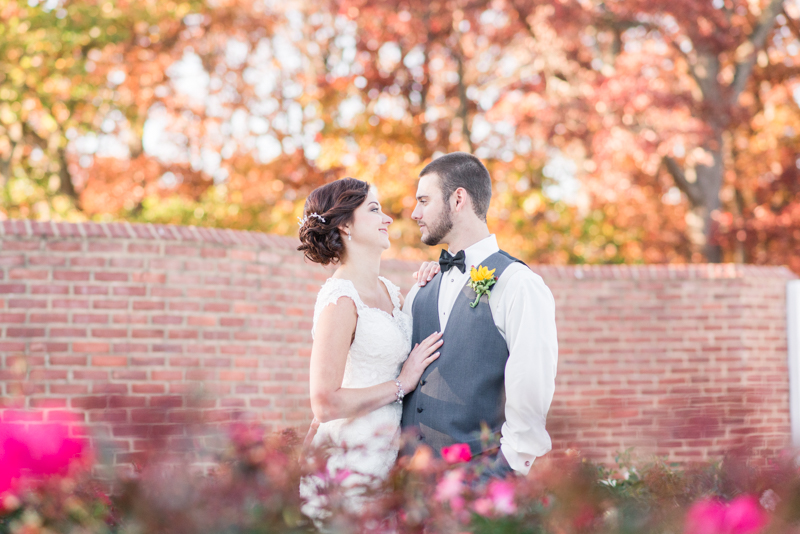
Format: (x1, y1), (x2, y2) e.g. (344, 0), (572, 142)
(0, 219), (798, 281)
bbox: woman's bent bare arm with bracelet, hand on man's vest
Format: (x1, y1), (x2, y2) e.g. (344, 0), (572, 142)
(309, 297), (441, 423)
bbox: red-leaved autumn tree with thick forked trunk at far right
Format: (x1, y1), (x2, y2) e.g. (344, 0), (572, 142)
(500, 0), (800, 262)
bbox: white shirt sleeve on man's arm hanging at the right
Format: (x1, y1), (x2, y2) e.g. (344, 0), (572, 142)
(496, 265), (558, 474)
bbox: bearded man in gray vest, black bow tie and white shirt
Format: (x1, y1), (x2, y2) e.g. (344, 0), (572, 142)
(402, 152), (558, 477)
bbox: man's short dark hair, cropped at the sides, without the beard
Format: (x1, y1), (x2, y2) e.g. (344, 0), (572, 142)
(419, 152), (492, 221)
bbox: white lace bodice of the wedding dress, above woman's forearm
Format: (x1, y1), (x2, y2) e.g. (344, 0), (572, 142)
(311, 276), (411, 388)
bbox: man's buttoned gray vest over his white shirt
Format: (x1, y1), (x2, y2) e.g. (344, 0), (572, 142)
(402, 251), (521, 455)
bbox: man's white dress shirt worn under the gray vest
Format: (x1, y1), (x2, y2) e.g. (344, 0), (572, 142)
(403, 235), (558, 474)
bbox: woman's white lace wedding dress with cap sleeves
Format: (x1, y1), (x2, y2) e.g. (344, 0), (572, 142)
(300, 277), (411, 520)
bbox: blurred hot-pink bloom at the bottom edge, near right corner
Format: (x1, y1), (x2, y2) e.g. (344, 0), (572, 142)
(684, 495), (769, 534)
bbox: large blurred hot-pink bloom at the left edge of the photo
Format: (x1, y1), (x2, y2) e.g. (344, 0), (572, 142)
(0, 423), (85, 494)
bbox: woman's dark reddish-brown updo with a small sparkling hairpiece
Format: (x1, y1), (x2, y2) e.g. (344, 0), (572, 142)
(297, 178), (369, 265)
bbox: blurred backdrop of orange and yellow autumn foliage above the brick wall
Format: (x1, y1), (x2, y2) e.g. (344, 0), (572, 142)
(0, 0), (800, 268)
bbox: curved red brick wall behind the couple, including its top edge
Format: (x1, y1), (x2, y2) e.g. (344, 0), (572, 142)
(0, 221), (793, 462)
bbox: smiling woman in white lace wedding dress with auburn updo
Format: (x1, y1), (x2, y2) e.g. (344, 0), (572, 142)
(298, 178), (442, 521)
